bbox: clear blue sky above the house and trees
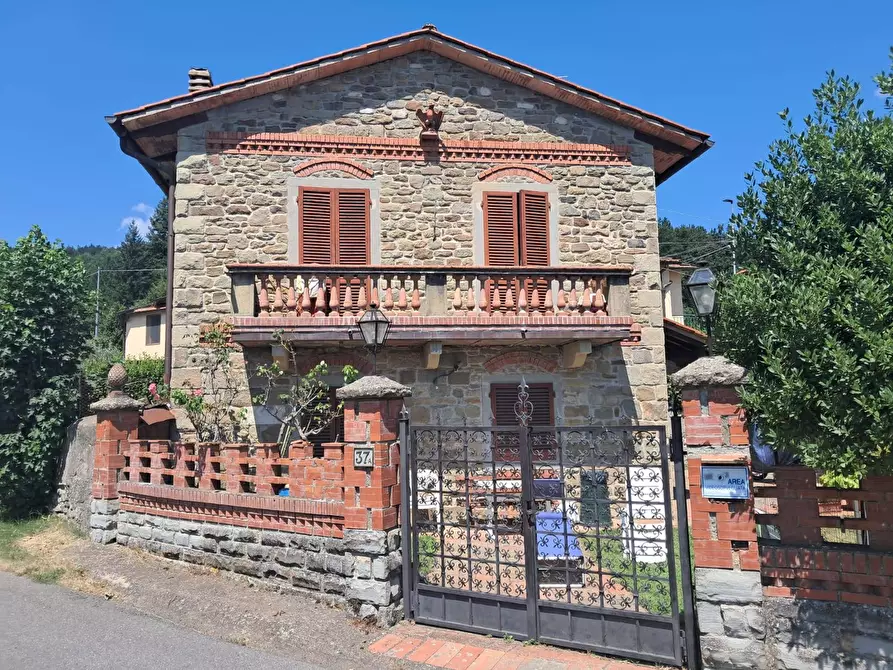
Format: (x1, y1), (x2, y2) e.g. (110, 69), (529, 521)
(0, 0), (893, 245)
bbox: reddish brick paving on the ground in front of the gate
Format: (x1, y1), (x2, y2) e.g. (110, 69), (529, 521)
(369, 623), (660, 670)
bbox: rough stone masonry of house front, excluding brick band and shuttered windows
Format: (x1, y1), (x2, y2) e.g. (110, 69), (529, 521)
(172, 53), (666, 430)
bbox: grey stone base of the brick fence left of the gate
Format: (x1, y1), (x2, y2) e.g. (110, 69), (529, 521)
(116, 511), (403, 626)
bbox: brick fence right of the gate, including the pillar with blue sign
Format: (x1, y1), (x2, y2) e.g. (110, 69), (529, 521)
(683, 368), (893, 670)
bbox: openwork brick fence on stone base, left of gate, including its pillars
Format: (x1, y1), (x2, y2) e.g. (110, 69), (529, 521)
(90, 392), (403, 624)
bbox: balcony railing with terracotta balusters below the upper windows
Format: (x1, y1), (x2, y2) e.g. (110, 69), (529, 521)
(228, 264), (631, 318)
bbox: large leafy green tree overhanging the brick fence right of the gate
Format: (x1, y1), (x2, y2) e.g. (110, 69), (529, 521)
(718, 51), (893, 485)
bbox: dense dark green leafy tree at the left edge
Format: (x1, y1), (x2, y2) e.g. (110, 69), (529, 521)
(0, 226), (90, 516)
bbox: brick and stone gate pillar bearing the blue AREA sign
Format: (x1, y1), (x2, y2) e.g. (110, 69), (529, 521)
(671, 356), (769, 668)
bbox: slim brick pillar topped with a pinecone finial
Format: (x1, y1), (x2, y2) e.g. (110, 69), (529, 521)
(90, 363), (142, 544)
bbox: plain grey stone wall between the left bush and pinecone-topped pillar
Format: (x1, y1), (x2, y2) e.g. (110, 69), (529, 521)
(53, 416), (96, 533)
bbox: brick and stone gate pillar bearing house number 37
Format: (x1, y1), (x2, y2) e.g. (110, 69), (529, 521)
(337, 376), (411, 624)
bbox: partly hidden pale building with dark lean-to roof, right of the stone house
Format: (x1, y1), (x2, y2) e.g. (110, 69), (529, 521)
(660, 257), (707, 373)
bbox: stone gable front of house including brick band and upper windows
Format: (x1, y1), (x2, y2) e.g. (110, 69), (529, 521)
(171, 51), (666, 438)
